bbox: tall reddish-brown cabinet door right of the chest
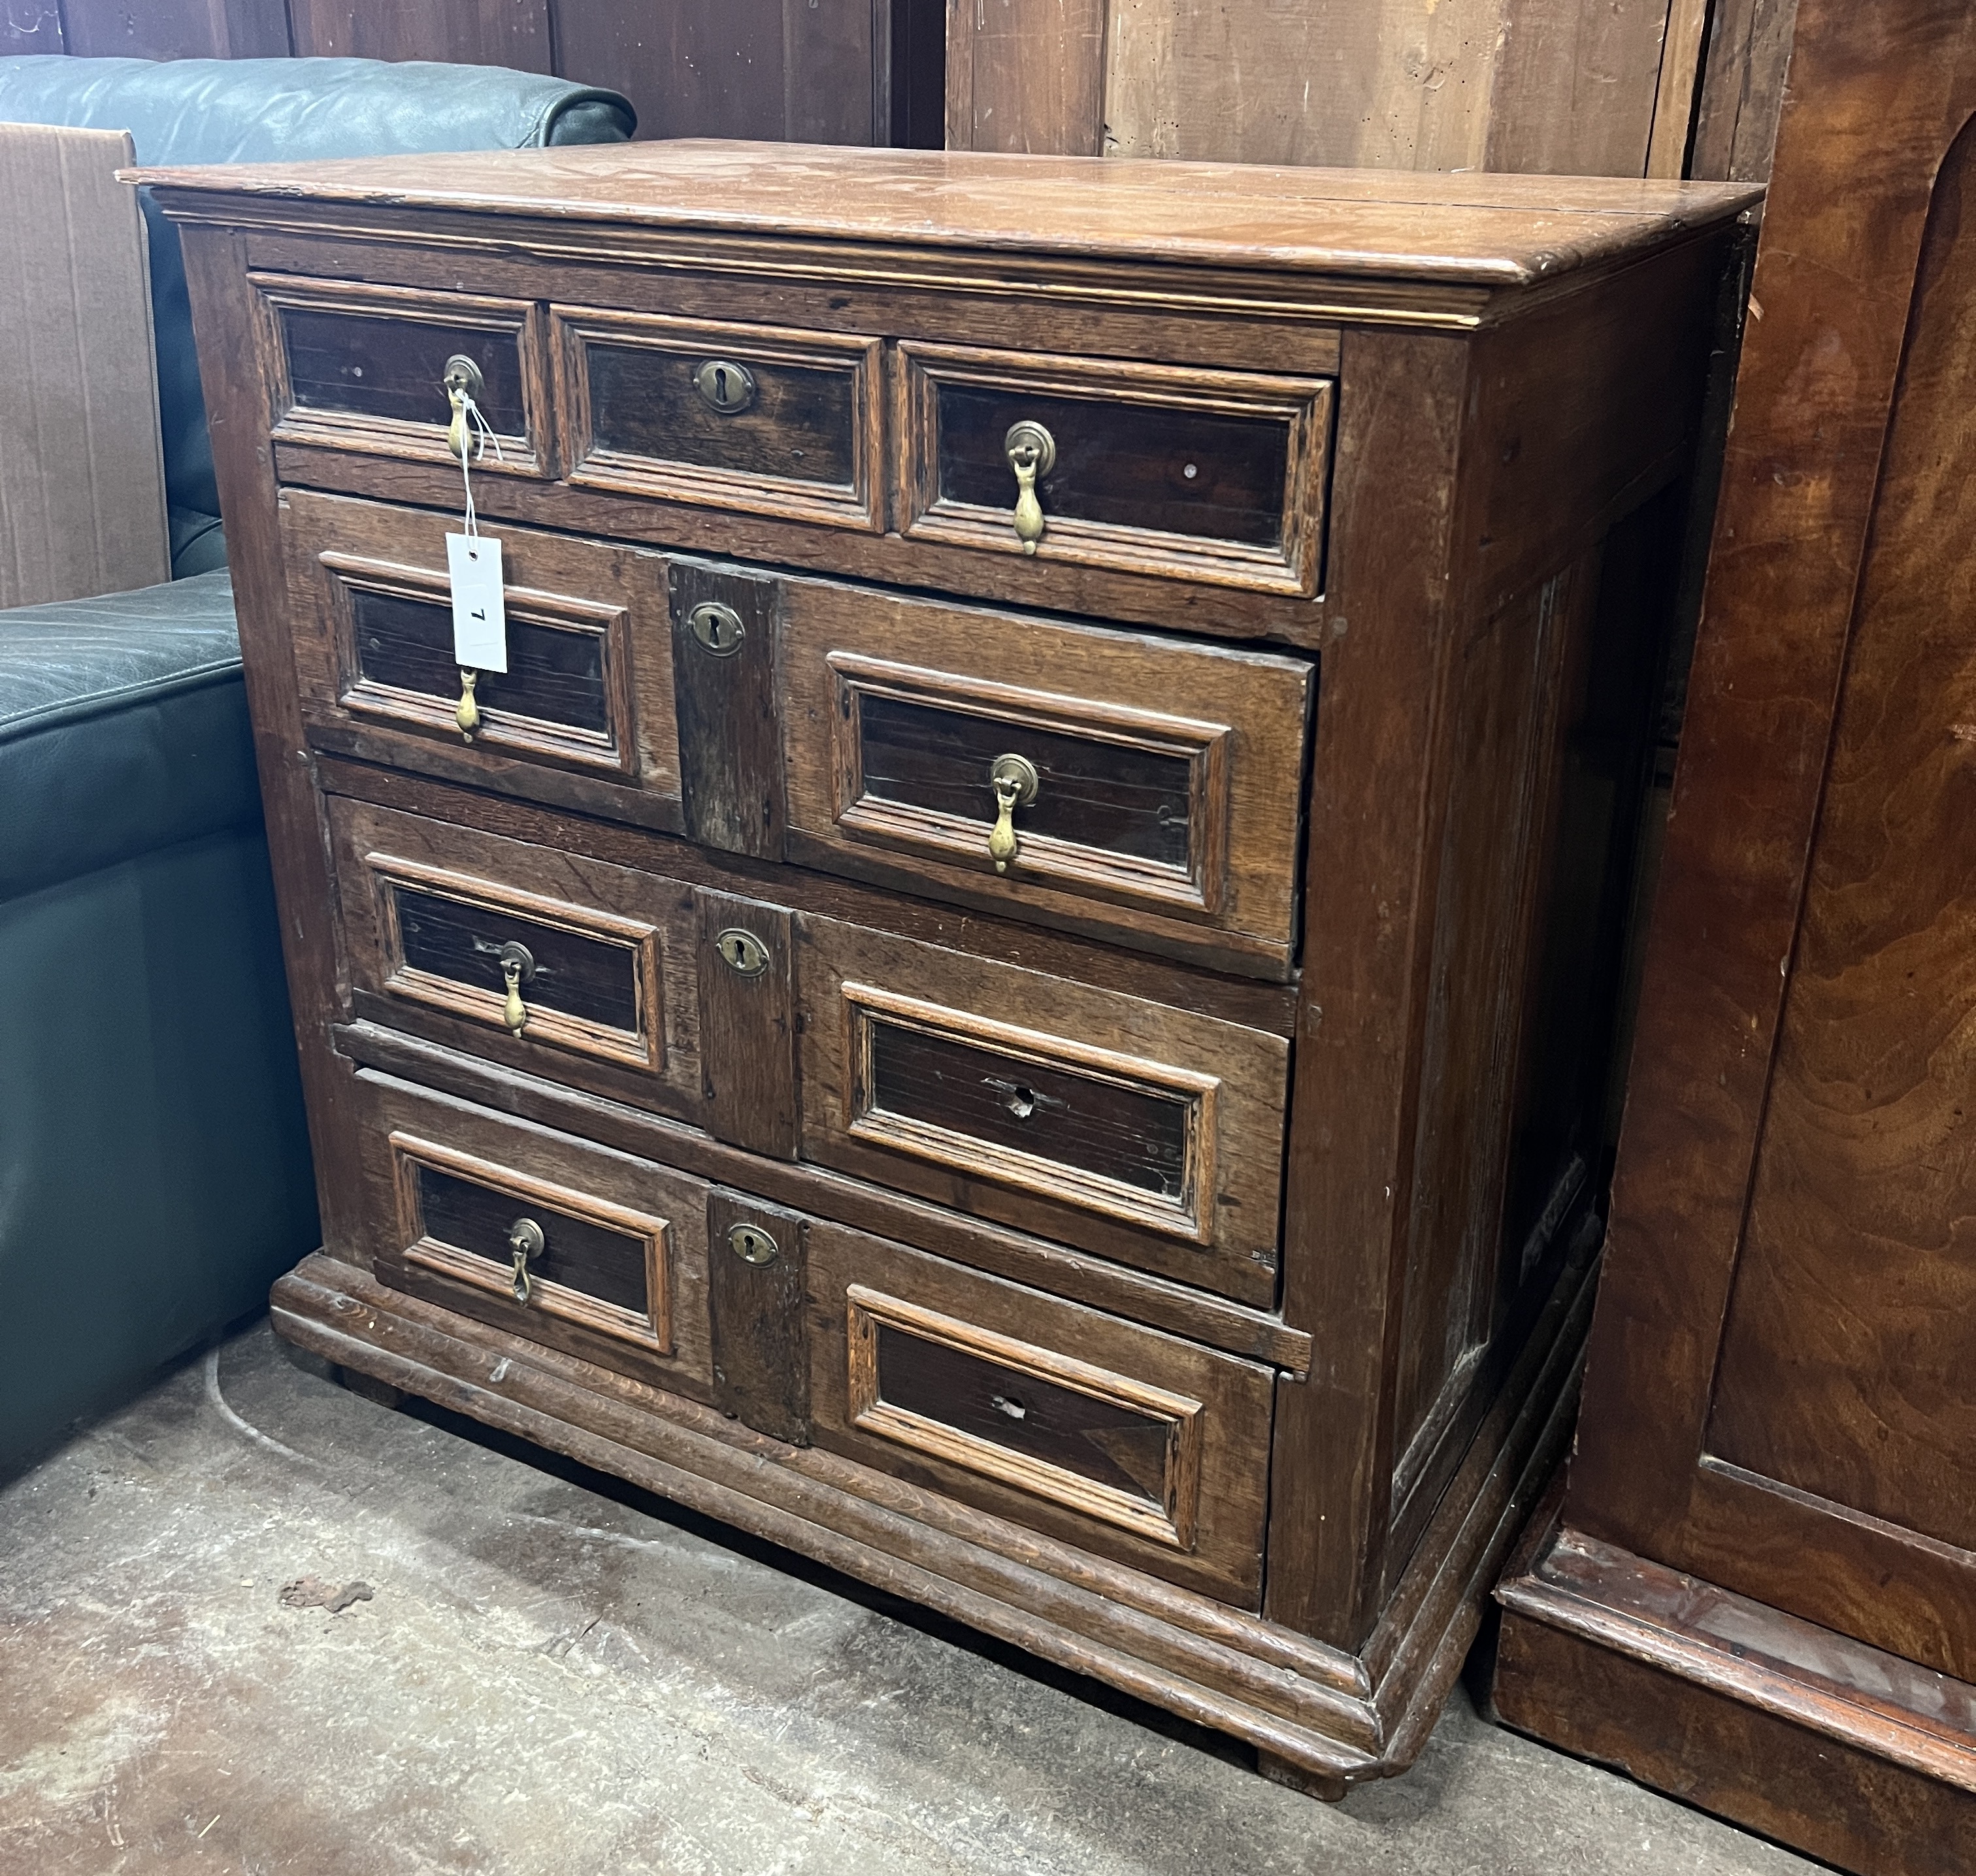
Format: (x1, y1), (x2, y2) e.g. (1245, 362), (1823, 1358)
(1567, 0), (1976, 1680)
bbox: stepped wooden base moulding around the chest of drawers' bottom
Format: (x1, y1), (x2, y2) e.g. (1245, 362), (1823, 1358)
(271, 1253), (1590, 1799)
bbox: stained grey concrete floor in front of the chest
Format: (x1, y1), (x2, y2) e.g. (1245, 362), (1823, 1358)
(0, 1323), (1812, 1876)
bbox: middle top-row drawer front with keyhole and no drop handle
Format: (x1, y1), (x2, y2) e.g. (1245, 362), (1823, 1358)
(555, 306), (883, 532)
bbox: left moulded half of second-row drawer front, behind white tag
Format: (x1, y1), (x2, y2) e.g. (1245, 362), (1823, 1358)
(282, 488), (680, 802)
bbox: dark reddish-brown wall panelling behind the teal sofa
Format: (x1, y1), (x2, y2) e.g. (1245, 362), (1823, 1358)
(0, 0), (944, 148)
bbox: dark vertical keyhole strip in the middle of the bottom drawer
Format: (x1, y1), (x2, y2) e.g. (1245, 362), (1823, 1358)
(708, 1188), (810, 1445)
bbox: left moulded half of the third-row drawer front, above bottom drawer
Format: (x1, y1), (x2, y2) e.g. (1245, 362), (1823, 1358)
(330, 797), (702, 1117)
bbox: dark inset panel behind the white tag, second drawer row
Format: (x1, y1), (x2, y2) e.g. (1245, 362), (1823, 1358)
(350, 581), (616, 735)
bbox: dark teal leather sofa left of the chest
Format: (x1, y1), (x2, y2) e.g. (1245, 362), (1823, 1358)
(0, 58), (636, 1477)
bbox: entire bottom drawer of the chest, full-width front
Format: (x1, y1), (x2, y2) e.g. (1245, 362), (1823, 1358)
(355, 1070), (1274, 1609)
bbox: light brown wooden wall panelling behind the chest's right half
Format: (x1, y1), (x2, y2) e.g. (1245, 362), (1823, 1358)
(946, 0), (1796, 180)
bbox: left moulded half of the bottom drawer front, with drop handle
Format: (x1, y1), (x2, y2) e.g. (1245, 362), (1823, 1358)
(357, 1074), (712, 1396)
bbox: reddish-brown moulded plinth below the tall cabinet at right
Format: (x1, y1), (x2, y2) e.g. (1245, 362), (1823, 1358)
(1494, 1522), (1976, 1876)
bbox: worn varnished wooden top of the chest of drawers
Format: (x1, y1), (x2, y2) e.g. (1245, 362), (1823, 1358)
(131, 140), (1754, 287)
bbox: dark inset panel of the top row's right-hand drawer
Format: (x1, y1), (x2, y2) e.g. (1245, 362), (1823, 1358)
(934, 384), (1291, 546)
